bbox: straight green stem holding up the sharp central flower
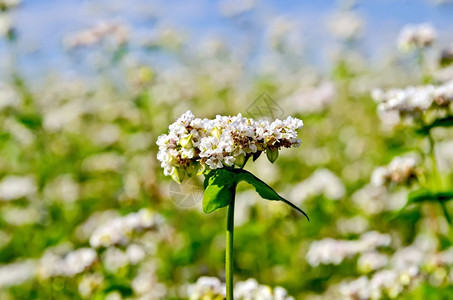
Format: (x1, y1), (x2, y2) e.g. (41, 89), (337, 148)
(225, 186), (236, 300)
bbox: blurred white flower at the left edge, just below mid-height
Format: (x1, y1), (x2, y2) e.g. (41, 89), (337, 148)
(0, 175), (37, 201)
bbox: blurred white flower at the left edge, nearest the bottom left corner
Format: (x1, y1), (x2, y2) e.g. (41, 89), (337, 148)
(0, 260), (36, 289)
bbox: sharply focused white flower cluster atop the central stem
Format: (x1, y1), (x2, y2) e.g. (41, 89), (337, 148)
(157, 111), (303, 182)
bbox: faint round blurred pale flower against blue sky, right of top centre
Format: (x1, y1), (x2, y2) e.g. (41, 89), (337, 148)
(327, 11), (365, 40)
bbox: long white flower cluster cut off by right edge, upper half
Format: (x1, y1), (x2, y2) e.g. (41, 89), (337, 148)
(371, 81), (453, 115)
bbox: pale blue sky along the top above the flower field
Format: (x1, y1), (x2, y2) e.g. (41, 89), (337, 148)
(0, 0), (453, 78)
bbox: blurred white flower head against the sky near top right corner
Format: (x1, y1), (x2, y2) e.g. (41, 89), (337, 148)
(398, 23), (436, 52)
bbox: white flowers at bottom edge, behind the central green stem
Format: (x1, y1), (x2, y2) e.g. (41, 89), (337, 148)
(189, 277), (294, 300)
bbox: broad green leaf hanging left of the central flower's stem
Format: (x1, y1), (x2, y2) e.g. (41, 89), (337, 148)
(203, 169), (236, 214)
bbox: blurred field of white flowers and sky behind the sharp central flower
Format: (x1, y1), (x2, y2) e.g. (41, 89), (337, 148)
(0, 0), (453, 300)
